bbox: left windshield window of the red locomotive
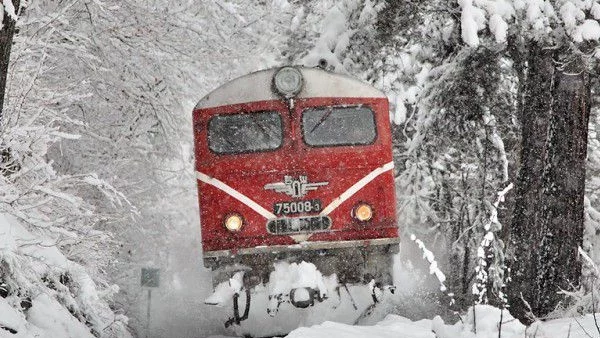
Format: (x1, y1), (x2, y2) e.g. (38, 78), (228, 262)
(208, 111), (283, 154)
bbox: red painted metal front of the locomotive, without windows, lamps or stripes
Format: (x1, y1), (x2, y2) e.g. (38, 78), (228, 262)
(193, 67), (398, 255)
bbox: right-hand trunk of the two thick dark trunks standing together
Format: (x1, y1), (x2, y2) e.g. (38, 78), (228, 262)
(534, 60), (590, 316)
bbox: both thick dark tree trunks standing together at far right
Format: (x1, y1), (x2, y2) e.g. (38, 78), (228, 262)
(508, 46), (590, 322)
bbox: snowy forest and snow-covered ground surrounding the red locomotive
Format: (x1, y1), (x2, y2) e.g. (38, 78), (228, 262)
(0, 0), (600, 338)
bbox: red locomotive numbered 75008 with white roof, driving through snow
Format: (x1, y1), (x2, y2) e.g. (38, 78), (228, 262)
(193, 67), (400, 322)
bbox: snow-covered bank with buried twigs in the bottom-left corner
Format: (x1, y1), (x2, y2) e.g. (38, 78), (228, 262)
(0, 213), (130, 338)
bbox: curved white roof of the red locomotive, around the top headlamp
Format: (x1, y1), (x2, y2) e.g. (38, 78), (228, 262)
(196, 67), (386, 109)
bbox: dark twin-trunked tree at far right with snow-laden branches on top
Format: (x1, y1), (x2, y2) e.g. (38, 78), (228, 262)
(461, 1), (600, 320)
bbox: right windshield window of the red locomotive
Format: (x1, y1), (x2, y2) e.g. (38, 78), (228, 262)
(302, 106), (377, 146)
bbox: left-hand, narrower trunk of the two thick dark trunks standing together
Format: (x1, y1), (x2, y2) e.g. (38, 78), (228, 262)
(507, 45), (554, 320)
